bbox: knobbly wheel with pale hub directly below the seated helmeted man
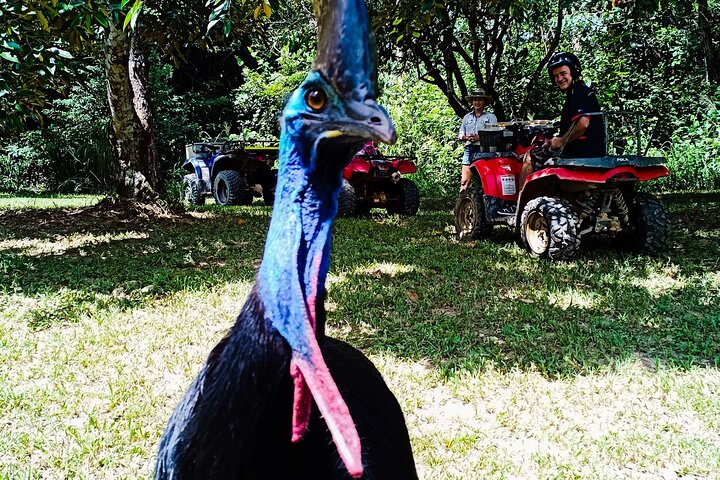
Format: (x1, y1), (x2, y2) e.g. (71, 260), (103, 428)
(520, 197), (580, 260)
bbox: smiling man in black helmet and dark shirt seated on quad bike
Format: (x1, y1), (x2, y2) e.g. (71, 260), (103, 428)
(513, 52), (605, 193)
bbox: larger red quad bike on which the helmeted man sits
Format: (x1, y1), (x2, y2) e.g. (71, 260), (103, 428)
(455, 112), (669, 260)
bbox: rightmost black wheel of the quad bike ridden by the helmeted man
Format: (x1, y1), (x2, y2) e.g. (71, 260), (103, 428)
(630, 193), (670, 253)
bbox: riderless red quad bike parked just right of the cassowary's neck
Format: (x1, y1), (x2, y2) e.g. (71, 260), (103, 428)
(338, 145), (420, 217)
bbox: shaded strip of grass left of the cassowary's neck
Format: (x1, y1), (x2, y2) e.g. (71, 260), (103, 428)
(0, 204), (269, 329)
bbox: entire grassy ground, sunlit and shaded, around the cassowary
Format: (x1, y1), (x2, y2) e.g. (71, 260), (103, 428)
(0, 193), (720, 480)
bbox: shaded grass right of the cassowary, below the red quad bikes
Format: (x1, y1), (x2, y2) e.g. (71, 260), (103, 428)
(329, 194), (720, 377)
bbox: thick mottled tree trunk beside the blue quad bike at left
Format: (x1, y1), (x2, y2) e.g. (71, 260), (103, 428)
(105, 21), (160, 201)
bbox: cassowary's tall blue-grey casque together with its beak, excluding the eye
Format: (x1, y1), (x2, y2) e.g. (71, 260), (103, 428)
(313, 0), (396, 144)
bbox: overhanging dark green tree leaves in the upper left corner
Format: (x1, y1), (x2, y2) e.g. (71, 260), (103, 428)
(0, 0), (272, 132)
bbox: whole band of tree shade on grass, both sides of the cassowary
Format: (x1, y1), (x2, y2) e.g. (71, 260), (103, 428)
(0, 194), (720, 377)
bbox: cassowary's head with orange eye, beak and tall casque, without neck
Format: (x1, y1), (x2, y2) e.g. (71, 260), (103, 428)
(282, 0), (395, 187)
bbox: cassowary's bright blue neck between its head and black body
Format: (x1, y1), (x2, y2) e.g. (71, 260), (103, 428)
(258, 124), (359, 344)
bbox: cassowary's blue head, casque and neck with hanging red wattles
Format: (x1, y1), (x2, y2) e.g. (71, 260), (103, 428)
(258, 0), (395, 477)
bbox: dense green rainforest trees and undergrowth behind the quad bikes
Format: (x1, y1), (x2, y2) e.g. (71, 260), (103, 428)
(0, 0), (720, 199)
